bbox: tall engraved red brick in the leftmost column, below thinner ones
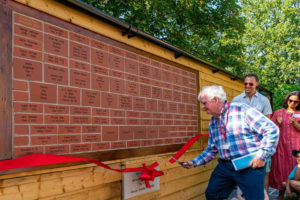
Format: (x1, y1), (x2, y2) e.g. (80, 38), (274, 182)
(13, 58), (42, 81)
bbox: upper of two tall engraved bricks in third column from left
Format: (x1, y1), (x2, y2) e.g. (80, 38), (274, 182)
(70, 42), (90, 63)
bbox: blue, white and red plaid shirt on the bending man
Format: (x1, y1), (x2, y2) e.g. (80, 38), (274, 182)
(192, 102), (279, 167)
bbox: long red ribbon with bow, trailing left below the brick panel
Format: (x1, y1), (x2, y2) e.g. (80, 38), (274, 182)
(0, 154), (164, 188)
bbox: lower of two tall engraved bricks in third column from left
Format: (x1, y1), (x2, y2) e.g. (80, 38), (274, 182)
(70, 69), (90, 88)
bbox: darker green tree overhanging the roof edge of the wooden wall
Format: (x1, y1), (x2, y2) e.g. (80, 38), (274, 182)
(85, 0), (245, 73)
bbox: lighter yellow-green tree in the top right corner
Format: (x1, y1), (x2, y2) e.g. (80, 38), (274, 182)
(241, 0), (300, 91)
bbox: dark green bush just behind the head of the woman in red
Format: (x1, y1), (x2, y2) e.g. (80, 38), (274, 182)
(273, 84), (300, 111)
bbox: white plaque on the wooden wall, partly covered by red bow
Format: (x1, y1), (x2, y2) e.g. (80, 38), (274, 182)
(122, 167), (160, 200)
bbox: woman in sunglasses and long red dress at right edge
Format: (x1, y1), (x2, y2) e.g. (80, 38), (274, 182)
(270, 91), (300, 200)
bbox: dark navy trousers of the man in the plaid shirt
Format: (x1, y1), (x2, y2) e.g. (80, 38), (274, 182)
(205, 159), (265, 200)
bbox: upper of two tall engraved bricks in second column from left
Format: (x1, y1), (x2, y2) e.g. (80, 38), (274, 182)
(44, 34), (68, 57)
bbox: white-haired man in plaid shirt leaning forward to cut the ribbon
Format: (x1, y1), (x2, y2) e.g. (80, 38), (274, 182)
(183, 85), (279, 200)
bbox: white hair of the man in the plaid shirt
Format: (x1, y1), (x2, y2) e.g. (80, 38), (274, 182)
(198, 85), (227, 102)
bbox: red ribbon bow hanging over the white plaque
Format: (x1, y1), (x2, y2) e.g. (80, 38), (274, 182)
(140, 162), (164, 188)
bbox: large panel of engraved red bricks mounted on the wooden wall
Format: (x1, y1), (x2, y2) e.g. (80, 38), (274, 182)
(11, 12), (198, 157)
